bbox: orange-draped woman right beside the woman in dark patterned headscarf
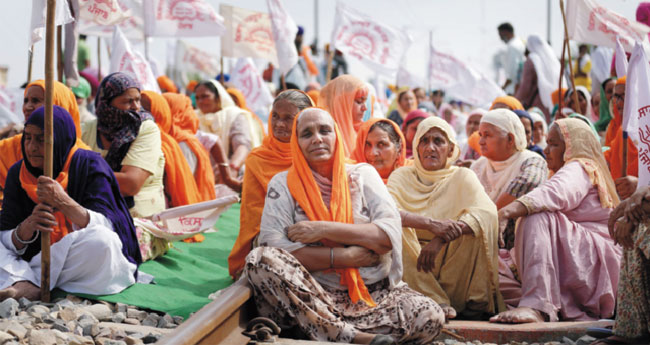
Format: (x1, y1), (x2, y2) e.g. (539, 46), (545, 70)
(142, 91), (201, 207)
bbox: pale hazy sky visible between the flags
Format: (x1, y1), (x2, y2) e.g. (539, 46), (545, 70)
(0, 0), (639, 87)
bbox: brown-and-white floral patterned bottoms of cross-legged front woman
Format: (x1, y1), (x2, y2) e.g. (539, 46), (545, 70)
(244, 247), (445, 344)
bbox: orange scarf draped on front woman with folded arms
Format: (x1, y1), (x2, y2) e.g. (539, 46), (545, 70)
(287, 109), (376, 307)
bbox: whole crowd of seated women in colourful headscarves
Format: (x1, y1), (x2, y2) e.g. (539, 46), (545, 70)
(0, 73), (650, 344)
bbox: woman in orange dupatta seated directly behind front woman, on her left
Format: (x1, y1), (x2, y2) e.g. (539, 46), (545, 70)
(228, 90), (314, 279)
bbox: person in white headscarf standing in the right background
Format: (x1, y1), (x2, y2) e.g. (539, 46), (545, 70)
(515, 35), (560, 120)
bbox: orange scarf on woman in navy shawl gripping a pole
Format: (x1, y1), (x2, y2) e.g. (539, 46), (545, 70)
(19, 144), (79, 244)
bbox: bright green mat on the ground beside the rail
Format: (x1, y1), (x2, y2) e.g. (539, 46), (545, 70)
(69, 204), (240, 318)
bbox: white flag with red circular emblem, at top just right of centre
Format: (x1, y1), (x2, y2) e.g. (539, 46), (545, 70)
(332, 2), (411, 76)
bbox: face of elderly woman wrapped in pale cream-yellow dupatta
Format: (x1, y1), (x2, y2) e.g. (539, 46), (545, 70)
(417, 128), (454, 171)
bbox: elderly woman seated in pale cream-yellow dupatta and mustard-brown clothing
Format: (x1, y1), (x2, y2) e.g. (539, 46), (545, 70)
(387, 117), (505, 318)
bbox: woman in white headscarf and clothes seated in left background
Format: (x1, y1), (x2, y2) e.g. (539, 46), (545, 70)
(194, 80), (262, 171)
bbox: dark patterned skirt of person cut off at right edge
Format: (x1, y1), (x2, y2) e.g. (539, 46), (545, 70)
(614, 223), (650, 338)
